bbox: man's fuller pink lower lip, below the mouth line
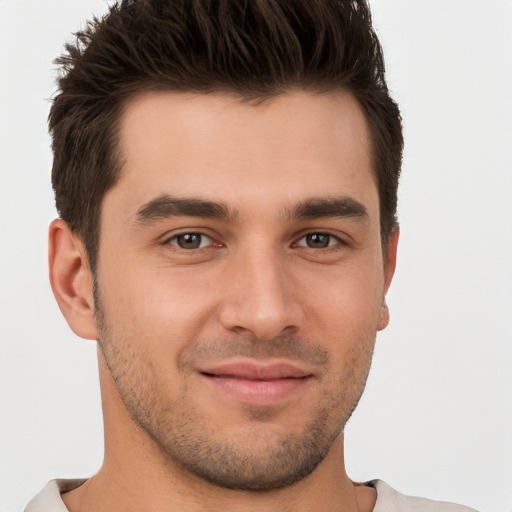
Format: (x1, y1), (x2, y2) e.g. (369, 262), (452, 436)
(203, 374), (311, 405)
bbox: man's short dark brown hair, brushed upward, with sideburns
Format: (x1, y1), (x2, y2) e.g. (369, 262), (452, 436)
(49, 0), (403, 270)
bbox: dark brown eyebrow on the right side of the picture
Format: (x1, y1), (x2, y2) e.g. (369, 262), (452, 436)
(286, 197), (369, 220)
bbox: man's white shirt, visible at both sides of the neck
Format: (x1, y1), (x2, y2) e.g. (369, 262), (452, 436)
(25, 480), (476, 512)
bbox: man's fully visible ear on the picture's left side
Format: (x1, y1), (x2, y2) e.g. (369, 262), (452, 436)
(48, 219), (98, 340)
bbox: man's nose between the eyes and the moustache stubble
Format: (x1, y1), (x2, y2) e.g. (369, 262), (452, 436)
(220, 244), (303, 340)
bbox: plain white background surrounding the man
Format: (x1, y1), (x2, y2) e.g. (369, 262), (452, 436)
(0, 0), (512, 512)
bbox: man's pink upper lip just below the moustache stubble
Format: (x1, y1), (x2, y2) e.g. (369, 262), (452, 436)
(200, 361), (311, 380)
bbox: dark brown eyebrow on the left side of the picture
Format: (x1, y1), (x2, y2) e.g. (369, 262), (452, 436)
(135, 194), (237, 224)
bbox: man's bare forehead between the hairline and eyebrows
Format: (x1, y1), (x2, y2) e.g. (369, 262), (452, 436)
(110, 91), (378, 220)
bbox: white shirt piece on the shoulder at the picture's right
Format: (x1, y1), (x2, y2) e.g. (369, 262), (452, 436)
(366, 480), (477, 512)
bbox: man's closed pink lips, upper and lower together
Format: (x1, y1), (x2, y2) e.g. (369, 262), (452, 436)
(200, 361), (313, 405)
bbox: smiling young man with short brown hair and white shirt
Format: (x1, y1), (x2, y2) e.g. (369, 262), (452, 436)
(26, 0), (476, 512)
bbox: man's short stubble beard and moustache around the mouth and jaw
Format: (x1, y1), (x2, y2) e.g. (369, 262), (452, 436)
(96, 295), (373, 491)
